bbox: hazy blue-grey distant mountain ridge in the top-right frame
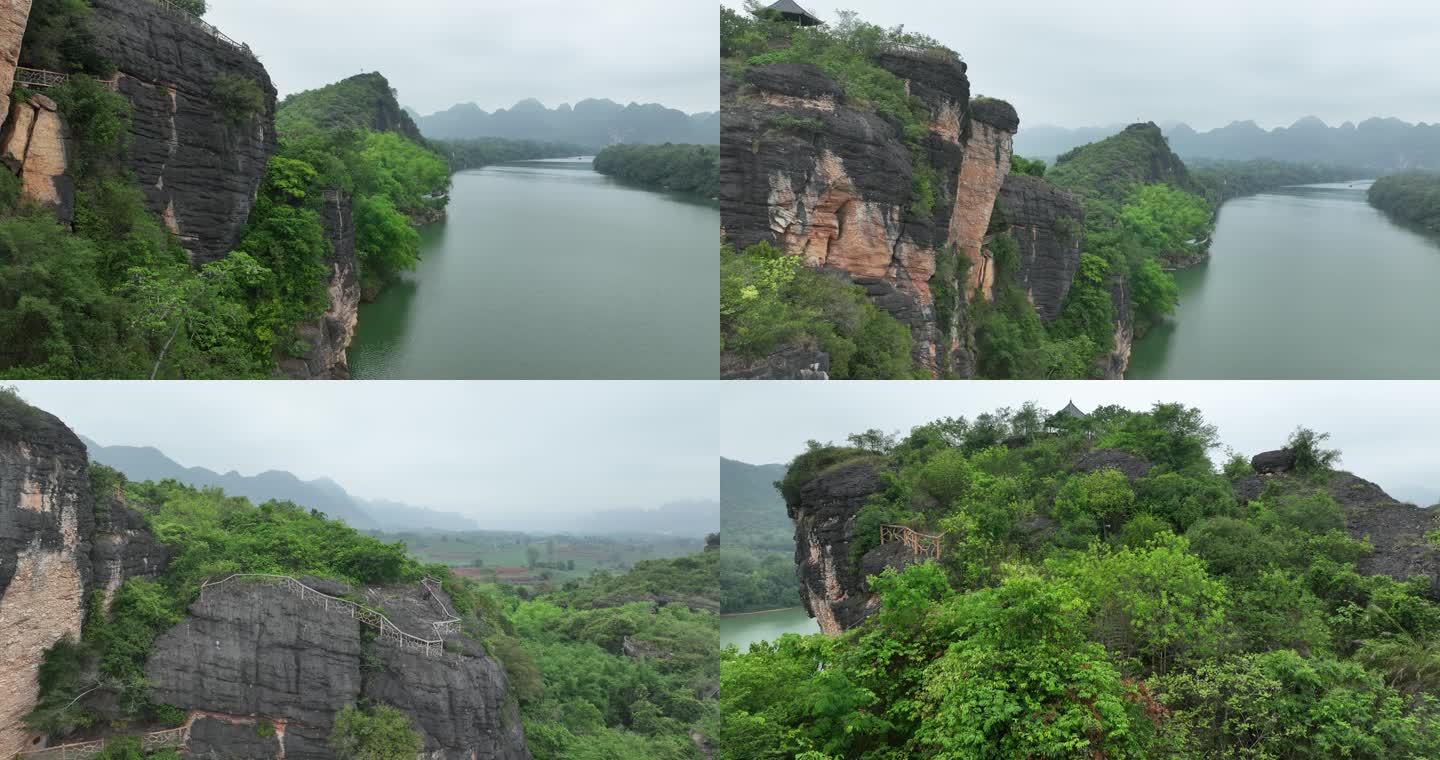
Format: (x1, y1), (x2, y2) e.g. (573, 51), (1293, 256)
(1015, 117), (1440, 171)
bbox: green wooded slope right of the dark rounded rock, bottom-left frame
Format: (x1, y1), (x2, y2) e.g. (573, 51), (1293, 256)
(510, 551), (720, 760)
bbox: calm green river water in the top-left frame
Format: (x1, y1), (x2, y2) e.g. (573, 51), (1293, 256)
(350, 160), (720, 380)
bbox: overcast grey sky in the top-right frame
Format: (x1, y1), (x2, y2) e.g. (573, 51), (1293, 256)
(724, 0), (1440, 130)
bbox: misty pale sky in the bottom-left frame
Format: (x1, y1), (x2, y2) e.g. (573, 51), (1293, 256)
(5, 381), (719, 524)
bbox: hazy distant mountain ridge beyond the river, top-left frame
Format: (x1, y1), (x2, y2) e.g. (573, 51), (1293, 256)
(416, 98), (720, 148)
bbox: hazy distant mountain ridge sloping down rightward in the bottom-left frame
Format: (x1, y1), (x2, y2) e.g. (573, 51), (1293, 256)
(81, 436), (480, 531)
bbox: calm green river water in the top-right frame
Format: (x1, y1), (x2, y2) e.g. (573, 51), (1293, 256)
(1126, 181), (1440, 380)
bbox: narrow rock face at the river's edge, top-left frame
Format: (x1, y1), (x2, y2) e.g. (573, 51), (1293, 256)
(279, 190), (360, 380)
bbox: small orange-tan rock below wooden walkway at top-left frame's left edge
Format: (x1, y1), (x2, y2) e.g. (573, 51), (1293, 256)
(0, 94), (75, 225)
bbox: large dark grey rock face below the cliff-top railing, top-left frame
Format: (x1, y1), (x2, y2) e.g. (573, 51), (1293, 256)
(88, 0), (275, 263)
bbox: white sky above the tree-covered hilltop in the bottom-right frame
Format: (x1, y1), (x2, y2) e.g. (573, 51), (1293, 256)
(720, 381), (1440, 505)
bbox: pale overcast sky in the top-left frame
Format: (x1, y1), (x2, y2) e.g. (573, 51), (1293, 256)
(206, 0), (720, 114)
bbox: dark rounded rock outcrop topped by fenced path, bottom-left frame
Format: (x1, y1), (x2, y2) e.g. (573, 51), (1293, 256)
(145, 579), (530, 760)
